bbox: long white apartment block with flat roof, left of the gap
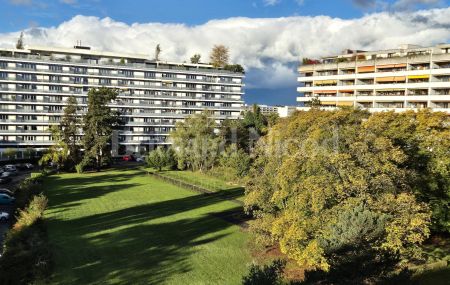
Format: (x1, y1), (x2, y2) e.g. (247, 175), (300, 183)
(0, 46), (244, 154)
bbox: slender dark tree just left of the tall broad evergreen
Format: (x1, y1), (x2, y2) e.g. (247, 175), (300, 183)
(60, 96), (81, 169)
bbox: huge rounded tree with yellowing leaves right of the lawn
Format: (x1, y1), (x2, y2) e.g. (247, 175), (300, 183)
(245, 109), (430, 272)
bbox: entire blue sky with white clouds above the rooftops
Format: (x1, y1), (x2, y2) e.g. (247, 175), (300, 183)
(0, 0), (450, 104)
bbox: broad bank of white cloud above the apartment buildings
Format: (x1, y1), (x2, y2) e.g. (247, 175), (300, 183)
(0, 8), (450, 91)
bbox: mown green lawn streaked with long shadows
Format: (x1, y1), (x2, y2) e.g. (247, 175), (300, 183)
(44, 170), (250, 284)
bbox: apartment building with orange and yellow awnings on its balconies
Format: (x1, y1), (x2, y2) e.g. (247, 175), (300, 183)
(297, 44), (450, 113)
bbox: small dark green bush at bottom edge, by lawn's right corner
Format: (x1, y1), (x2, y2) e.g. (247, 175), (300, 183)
(242, 260), (286, 285)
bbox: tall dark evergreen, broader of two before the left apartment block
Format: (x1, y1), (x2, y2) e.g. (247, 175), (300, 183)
(81, 87), (121, 171)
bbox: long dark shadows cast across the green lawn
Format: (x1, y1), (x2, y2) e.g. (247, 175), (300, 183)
(48, 170), (246, 284)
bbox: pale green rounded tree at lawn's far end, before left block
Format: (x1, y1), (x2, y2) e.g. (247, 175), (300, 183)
(170, 111), (221, 171)
